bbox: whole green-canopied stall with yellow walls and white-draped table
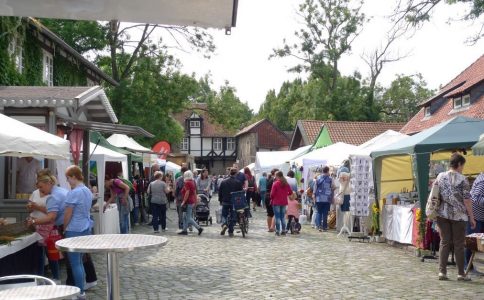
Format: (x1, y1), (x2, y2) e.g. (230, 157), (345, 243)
(371, 117), (484, 243)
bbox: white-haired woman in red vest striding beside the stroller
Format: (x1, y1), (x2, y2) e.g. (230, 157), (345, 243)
(178, 171), (203, 235)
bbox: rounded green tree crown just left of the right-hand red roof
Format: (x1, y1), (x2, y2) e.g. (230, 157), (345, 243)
(378, 74), (434, 122)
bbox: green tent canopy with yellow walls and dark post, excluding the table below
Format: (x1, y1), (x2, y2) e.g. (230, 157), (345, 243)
(371, 116), (484, 216)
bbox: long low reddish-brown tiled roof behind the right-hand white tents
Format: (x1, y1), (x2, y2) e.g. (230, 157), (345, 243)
(298, 120), (404, 145)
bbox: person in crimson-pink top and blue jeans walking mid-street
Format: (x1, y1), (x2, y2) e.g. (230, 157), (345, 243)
(271, 171), (293, 236)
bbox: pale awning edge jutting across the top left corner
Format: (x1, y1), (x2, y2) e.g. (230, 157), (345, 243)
(0, 0), (238, 28)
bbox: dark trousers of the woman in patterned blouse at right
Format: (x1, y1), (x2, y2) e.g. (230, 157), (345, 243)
(437, 217), (467, 275)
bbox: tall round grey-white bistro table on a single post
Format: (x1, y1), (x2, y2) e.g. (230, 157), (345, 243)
(56, 234), (168, 300)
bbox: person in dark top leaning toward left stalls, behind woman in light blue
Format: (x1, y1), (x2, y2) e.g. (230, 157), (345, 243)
(104, 176), (129, 234)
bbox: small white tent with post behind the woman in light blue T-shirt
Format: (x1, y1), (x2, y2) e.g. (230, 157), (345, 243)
(90, 143), (128, 233)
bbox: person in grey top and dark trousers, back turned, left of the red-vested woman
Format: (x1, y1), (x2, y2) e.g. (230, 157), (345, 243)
(148, 171), (170, 233)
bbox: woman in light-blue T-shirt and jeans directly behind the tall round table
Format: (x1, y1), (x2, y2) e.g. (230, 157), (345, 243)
(64, 166), (93, 295)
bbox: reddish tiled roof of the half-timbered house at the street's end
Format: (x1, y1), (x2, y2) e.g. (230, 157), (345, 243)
(173, 103), (234, 137)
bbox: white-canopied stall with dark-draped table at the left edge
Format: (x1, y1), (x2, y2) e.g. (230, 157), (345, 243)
(0, 114), (70, 276)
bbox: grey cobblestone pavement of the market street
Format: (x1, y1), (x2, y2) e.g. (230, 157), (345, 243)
(81, 201), (484, 299)
